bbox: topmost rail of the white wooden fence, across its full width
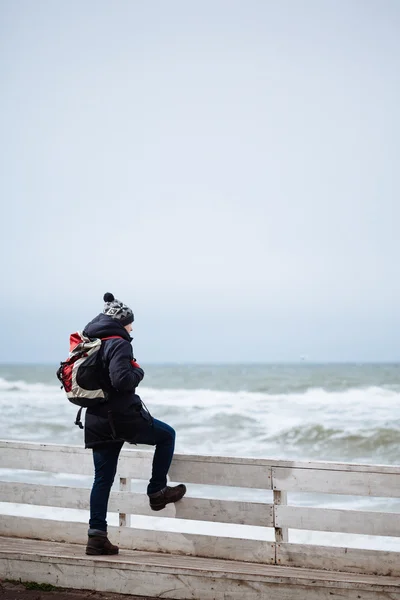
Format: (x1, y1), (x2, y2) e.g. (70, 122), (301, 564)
(0, 442), (400, 497)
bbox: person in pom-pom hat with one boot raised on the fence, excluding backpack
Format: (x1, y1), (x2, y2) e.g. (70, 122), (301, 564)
(83, 293), (186, 554)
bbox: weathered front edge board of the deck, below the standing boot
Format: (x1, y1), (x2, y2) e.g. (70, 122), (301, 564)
(0, 555), (400, 600)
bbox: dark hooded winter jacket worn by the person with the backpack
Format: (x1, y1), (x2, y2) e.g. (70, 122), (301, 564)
(83, 313), (152, 448)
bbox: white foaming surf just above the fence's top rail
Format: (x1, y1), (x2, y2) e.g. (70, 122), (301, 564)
(0, 379), (400, 463)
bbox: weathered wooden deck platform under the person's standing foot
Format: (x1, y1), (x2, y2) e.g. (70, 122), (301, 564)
(0, 538), (400, 600)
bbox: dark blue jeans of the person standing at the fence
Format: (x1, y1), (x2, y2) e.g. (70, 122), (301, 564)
(89, 419), (175, 533)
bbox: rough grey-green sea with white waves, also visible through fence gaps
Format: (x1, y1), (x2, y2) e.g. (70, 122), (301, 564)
(0, 362), (400, 551)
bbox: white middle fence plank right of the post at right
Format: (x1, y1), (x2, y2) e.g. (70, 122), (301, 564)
(275, 506), (400, 541)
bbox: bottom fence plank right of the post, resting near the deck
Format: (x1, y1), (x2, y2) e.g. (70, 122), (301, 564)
(276, 543), (400, 589)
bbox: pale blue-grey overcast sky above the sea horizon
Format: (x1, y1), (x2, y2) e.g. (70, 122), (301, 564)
(0, 0), (400, 363)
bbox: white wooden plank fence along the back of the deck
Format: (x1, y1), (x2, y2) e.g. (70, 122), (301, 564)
(0, 441), (400, 576)
